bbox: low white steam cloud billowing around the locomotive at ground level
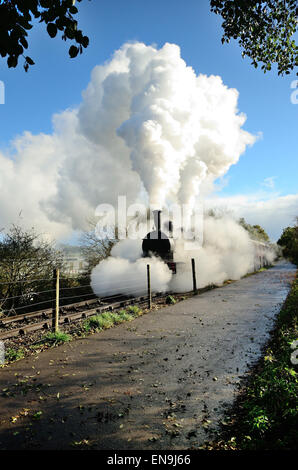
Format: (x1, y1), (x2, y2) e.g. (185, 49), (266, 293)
(92, 215), (275, 296)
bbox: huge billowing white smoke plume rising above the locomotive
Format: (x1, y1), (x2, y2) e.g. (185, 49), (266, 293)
(0, 43), (255, 237)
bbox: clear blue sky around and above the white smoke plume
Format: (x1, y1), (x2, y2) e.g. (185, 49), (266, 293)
(0, 0), (298, 237)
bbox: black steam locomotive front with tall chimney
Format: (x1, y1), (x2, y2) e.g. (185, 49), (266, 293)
(142, 210), (174, 262)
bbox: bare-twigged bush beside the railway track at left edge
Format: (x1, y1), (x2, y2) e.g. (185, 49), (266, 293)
(0, 225), (63, 311)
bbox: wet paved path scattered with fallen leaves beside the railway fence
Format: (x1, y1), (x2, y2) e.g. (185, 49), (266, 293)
(0, 262), (295, 450)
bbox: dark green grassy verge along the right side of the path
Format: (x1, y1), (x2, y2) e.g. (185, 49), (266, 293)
(206, 277), (298, 450)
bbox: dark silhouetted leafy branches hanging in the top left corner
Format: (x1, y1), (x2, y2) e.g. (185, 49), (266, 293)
(0, 0), (89, 72)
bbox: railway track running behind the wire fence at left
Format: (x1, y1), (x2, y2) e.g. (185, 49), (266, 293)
(0, 294), (166, 340)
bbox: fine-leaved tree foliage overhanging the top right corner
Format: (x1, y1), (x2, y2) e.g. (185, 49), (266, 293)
(211, 0), (298, 75)
